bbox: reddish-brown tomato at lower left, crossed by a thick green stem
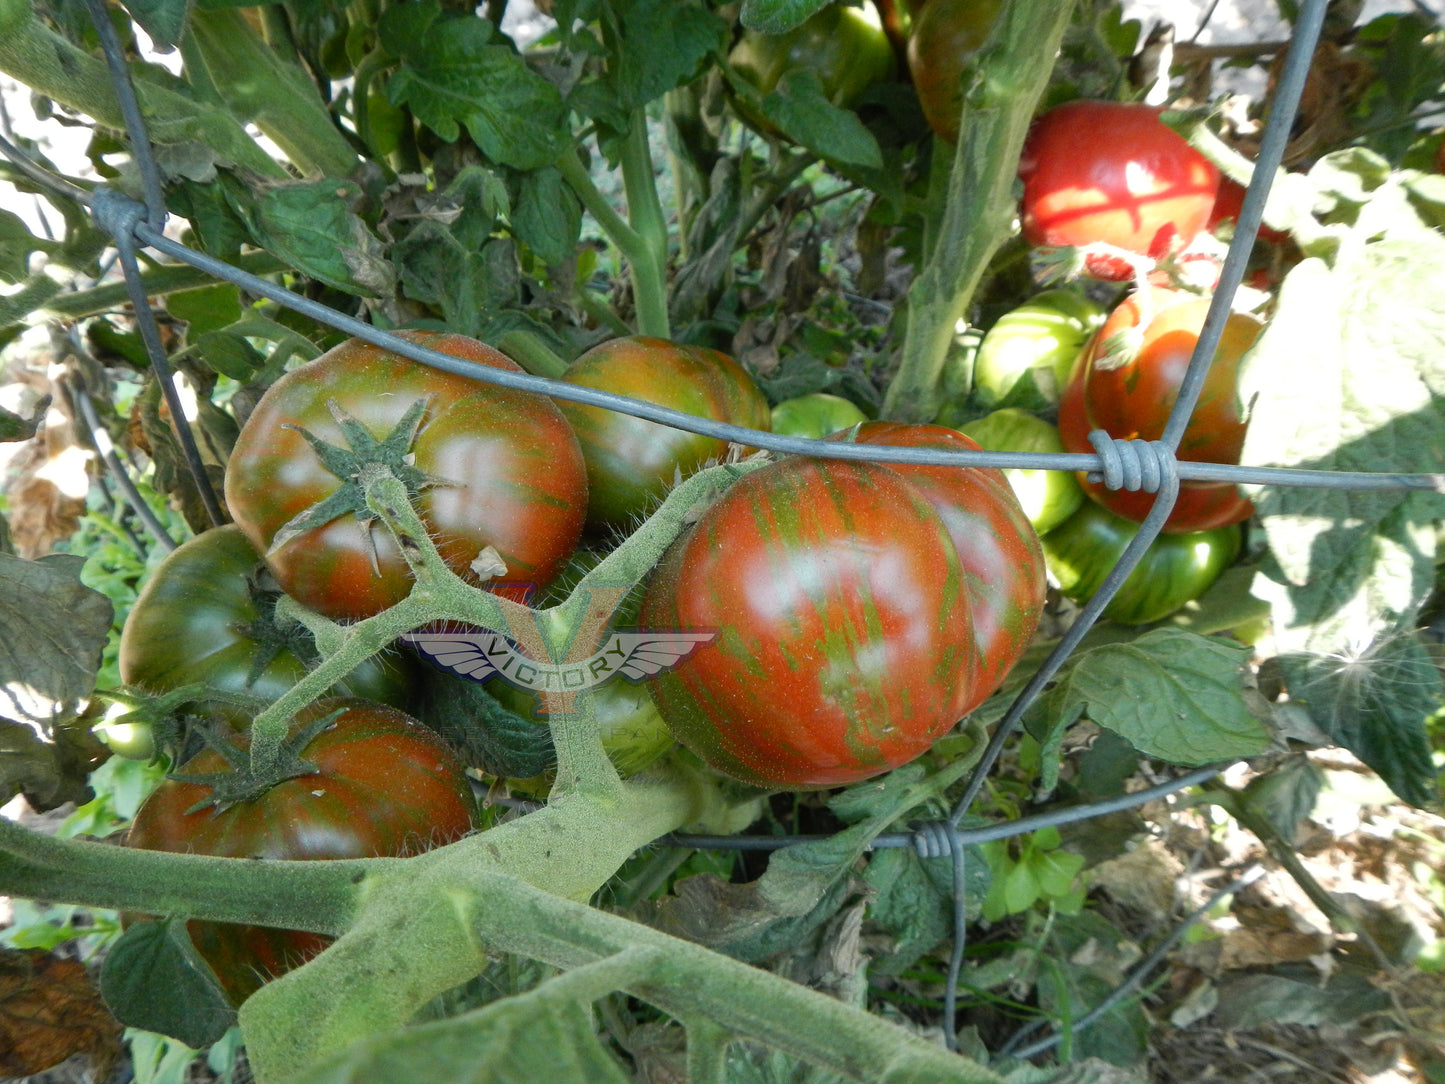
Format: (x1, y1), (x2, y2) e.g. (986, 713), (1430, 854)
(127, 700), (477, 1002)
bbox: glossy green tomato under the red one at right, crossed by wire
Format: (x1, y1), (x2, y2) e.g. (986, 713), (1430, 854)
(1043, 500), (1241, 624)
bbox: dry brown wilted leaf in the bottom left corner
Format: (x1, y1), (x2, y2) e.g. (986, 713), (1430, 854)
(0, 948), (120, 1080)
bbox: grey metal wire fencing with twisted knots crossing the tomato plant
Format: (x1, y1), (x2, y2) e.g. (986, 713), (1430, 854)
(0, 0), (1404, 1058)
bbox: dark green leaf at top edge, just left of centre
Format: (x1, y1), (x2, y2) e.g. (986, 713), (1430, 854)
(614, 0), (728, 110)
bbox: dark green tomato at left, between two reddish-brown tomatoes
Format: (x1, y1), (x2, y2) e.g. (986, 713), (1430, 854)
(117, 525), (412, 740)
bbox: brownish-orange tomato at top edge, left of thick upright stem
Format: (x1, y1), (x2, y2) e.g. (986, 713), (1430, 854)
(907, 0), (1003, 143)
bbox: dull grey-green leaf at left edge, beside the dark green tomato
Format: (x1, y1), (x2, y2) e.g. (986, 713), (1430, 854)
(0, 554), (111, 728)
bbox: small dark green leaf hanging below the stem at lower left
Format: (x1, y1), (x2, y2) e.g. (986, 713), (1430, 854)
(100, 918), (236, 1048)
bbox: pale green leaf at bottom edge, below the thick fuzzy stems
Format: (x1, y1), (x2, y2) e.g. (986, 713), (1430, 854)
(292, 968), (631, 1084)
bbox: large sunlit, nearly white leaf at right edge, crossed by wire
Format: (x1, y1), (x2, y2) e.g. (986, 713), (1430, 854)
(1240, 241), (1445, 653)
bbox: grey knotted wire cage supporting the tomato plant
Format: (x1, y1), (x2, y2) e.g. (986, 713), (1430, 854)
(0, 0), (1445, 1075)
